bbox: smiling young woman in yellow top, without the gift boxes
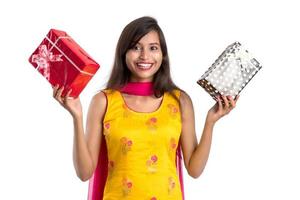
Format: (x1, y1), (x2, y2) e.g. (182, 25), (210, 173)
(53, 17), (237, 200)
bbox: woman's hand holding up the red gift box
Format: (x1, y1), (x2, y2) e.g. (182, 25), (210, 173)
(53, 85), (82, 118)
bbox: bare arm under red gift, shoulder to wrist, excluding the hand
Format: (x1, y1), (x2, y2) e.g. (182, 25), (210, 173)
(73, 92), (107, 181)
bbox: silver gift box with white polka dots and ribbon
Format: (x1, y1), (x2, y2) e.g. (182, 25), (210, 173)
(197, 42), (262, 101)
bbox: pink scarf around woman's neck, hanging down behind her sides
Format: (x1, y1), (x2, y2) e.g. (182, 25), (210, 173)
(88, 82), (184, 200)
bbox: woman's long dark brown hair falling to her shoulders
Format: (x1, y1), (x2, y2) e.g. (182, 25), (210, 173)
(106, 16), (182, 100)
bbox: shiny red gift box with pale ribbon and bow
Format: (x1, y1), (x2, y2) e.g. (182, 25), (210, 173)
(29, 29), (100, 98)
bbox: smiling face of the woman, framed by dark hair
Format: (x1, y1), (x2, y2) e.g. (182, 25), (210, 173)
(126, 31), (162, 82)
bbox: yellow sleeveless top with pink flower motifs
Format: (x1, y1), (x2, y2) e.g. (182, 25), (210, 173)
(103, 90), (182, 200)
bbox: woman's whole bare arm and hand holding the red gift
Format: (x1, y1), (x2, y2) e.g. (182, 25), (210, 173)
(54, 85), (107, 181)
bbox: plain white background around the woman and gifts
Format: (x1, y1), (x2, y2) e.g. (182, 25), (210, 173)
(0, 0), (300, 200)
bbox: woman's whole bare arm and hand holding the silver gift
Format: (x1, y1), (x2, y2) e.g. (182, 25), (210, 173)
(180, 93), (236, 178)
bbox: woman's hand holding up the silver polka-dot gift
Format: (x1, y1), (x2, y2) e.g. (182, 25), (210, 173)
(206, 96), (239, 124)
